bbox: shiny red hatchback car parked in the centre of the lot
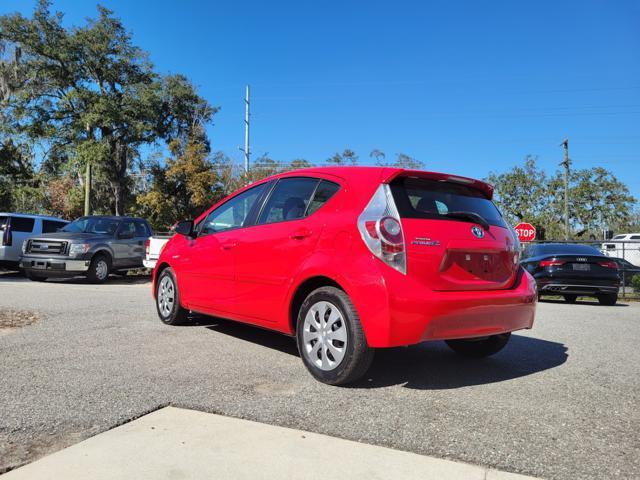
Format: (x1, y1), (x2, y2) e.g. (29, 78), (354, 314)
(153, 167), (537, 385)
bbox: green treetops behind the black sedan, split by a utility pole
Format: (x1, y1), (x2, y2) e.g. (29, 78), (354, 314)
(487, 155), (635, 240)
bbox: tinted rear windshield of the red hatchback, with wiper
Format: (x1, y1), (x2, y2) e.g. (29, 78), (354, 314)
(391, 177), (507, 228)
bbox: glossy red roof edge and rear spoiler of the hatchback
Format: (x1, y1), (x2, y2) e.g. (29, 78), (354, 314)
(269, 166), (493, 199)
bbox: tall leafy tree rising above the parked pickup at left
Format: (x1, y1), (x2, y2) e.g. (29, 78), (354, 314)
(0, 0), (216, 214)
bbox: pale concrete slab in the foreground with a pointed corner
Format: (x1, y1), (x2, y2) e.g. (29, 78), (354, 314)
(2, 407), (533, 480)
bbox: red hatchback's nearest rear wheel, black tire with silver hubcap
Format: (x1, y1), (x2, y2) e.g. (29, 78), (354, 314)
(296, 287), (375, 385)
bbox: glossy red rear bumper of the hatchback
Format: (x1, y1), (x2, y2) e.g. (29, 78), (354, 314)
(358, 269), (537, 347)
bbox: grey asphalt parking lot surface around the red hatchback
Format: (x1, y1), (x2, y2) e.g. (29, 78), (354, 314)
(0, 274), (640, 478)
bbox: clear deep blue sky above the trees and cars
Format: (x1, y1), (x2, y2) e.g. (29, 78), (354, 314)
(0, 0), (640, 198)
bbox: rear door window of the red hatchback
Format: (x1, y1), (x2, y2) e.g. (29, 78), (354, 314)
(258, 177), (319, 223)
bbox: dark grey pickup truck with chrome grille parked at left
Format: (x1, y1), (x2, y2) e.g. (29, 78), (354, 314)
(20, 216), (152, 283)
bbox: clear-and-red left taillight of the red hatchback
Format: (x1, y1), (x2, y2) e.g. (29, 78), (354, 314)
(358, 184), (407, 274)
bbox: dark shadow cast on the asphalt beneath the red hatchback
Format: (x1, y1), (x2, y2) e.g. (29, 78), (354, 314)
(191, 315), (568, 390)
